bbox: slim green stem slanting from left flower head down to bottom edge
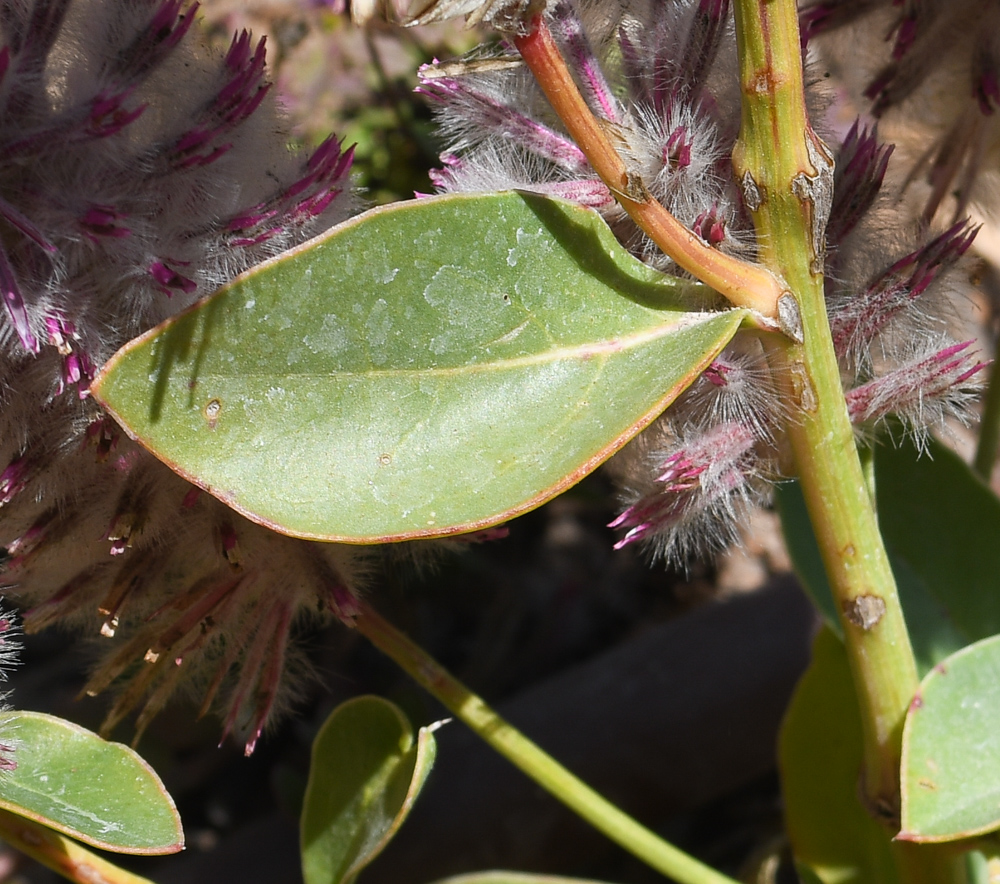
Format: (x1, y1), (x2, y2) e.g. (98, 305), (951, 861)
(355, 602), (737, 884)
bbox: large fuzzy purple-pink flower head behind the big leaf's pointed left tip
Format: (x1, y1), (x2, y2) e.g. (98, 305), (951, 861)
(0, 0), (355, 752)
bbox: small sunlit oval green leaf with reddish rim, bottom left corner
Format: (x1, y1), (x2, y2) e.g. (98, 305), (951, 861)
(0, 712), (184, 854)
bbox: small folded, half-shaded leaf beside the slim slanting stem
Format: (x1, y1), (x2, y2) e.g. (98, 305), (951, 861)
(300, 697), (437, 884)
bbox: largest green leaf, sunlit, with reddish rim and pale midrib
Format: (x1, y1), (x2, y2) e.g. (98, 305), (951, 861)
(91, 193), (745, 542)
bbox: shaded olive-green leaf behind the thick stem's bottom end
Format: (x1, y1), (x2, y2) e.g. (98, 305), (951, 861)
(778, 629), (898, 884)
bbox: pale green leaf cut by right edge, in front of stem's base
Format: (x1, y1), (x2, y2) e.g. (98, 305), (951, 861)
(898, 636), (1000, 841)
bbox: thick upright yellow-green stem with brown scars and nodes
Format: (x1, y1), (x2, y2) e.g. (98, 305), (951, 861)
(733, 0), (918, 827)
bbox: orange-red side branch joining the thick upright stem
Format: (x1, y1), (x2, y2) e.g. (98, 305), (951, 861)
(514, 16), (785, 319)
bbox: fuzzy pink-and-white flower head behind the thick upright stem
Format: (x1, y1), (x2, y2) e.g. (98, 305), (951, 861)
(419, 0), (983, 564)
